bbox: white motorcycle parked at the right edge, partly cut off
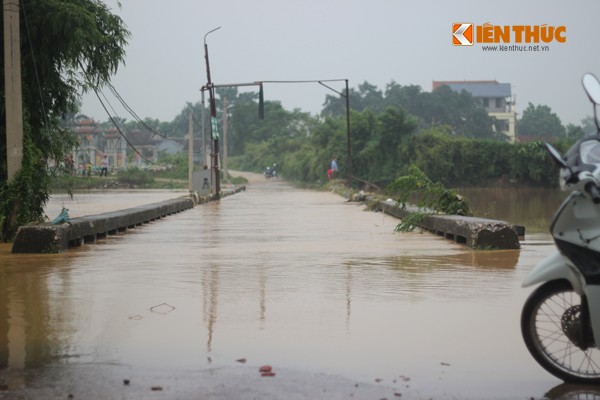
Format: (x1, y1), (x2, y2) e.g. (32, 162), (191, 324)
(521, 74), (600, 384)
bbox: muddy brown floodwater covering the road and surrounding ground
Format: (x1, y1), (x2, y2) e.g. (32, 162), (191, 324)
(0, 176), (583, 399)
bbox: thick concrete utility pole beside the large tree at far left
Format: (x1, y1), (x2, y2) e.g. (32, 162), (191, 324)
(3, 0), (23, 181)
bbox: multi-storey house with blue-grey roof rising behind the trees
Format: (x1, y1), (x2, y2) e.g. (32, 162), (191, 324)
(432, 80), (517, 142)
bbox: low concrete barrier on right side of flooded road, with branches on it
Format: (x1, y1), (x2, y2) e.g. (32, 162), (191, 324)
(374, 201), (522, 249)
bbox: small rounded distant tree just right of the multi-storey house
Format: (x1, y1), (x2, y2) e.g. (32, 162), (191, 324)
(518, 103), (565, 138)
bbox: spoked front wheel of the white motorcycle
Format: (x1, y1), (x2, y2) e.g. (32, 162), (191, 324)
(521, 281), (600, 384)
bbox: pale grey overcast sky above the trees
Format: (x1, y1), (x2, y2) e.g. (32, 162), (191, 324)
(82, 0), (600, 124)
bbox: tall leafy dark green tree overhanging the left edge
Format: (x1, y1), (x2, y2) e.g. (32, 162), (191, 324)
(0, 0), (129, 240)
